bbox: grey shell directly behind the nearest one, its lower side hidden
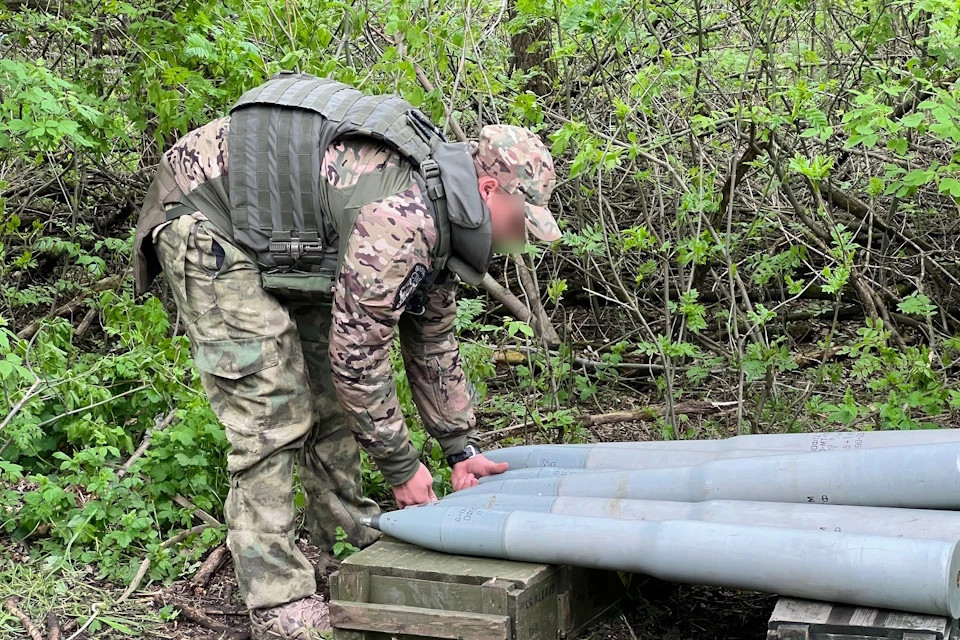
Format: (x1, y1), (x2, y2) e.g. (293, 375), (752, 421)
(433, 492), (960, 542)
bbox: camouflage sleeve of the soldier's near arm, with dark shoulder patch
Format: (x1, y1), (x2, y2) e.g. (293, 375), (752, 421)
(330, 184), (433, 486)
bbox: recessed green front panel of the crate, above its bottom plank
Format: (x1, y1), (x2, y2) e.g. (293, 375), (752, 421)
(370, 575), (484, 614)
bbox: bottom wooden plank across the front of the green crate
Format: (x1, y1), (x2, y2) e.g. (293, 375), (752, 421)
(330, 600), (510, 640)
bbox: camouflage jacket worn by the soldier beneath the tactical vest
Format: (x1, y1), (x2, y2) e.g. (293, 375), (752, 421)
(137, 118), (475, 485)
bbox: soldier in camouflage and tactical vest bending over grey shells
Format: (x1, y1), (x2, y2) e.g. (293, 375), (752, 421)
(135, 74), (560, 639)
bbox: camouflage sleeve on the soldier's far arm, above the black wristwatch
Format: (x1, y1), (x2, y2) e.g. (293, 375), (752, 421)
(400, 279), (475, 455)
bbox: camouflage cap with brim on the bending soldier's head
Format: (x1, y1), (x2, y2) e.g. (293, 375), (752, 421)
(477, 124), (561, 242)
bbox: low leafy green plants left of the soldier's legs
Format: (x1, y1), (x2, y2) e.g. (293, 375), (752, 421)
(0, 293), (226, 579)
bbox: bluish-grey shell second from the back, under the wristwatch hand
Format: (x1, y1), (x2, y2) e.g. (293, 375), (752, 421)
(464, 443), (960, 509)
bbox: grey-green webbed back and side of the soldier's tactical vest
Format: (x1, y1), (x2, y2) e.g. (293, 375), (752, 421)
(229, 73), (447, 268)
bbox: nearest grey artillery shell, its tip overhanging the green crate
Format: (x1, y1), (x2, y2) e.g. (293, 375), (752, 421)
(369, 508), (960, 617)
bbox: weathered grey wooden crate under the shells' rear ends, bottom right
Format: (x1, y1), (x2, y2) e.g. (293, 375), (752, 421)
(767, 598), (957, 640)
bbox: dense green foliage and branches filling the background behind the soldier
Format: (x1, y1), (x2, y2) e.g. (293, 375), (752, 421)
(0, 0), (960, 612)
